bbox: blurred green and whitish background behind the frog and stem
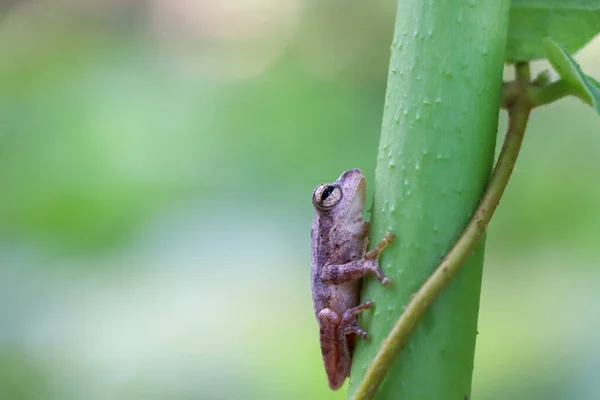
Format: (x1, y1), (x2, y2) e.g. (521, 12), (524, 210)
(0, 0), (600, 400)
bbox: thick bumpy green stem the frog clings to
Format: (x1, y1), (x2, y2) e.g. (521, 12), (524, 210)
(349, 0), (509, 400)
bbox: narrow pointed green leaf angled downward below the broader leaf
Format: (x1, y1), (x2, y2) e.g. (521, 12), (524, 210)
(544, 39), (600, 115)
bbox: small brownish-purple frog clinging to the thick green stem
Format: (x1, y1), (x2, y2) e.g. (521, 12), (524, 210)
(310, 169), (395, 390)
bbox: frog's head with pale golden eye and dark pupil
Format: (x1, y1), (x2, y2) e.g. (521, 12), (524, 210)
(313, 168), (366, 224)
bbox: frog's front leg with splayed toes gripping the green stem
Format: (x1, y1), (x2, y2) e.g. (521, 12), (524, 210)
(321, 232), (395, 286)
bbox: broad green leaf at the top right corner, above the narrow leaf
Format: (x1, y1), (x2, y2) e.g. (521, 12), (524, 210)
(504, 0), (600, 63)
